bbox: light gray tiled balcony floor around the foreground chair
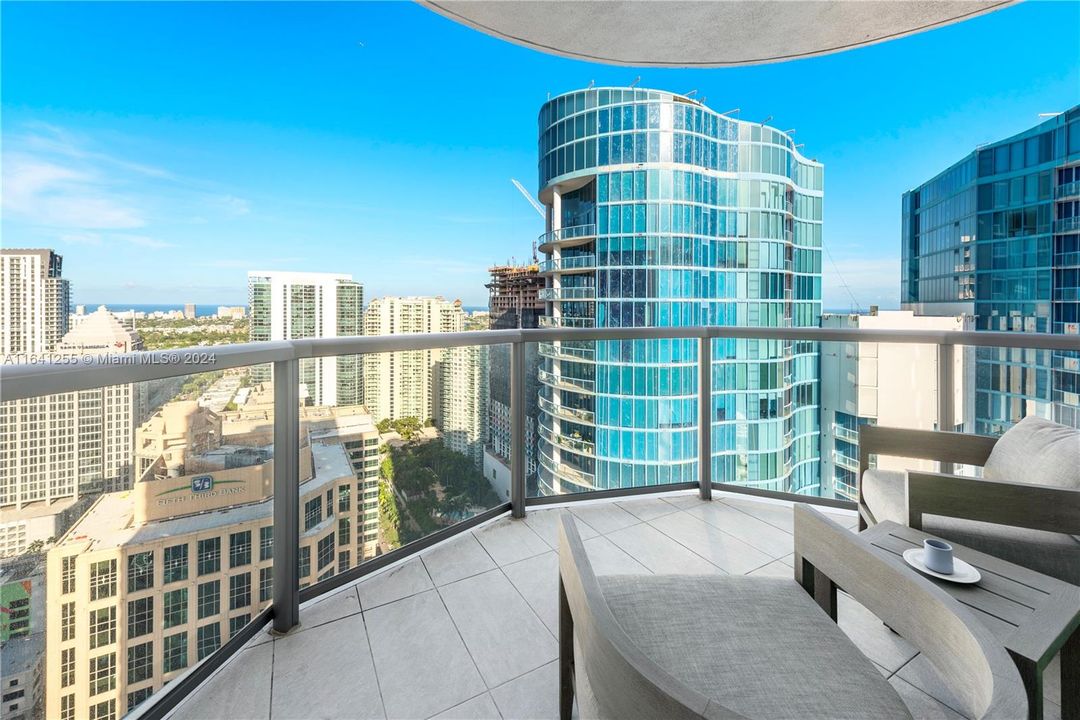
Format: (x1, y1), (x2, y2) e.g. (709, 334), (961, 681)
(179, 492), (989, 720)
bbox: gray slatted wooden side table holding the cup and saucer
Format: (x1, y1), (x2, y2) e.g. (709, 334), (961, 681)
(860, 521), (1080, 720)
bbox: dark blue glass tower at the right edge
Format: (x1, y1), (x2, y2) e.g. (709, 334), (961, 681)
(901, 106), (1080, 435)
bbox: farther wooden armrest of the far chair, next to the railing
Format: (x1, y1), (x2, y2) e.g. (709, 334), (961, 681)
(859, 425), (998, 477)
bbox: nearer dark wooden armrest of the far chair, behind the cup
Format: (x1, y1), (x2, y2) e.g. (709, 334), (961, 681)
(906, 472), (1080, 534)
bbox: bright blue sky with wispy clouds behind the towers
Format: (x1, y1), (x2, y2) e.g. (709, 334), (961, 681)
(0, 2), (1080, 308)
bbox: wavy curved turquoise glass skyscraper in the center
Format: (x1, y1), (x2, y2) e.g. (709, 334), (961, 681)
(538, 87), (823, 494)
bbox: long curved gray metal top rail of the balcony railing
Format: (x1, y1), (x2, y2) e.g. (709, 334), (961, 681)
(0, 326), (1080, 400)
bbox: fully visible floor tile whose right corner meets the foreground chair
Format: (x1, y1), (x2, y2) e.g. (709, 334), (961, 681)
(438, 569), (558, 688)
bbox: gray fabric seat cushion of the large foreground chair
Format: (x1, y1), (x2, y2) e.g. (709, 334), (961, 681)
(596, 575), (910, 719)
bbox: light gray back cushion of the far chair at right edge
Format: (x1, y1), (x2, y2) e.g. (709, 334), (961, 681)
(983, 415), (1080, 489)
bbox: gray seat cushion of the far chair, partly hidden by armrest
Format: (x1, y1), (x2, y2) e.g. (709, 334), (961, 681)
(863, 468), (1080, 585)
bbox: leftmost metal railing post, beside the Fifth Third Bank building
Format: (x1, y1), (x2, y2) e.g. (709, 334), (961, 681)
(273, 359), (300, 634)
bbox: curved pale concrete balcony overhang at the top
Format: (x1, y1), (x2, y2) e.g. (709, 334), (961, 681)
(420, 0), (1016, 67)
